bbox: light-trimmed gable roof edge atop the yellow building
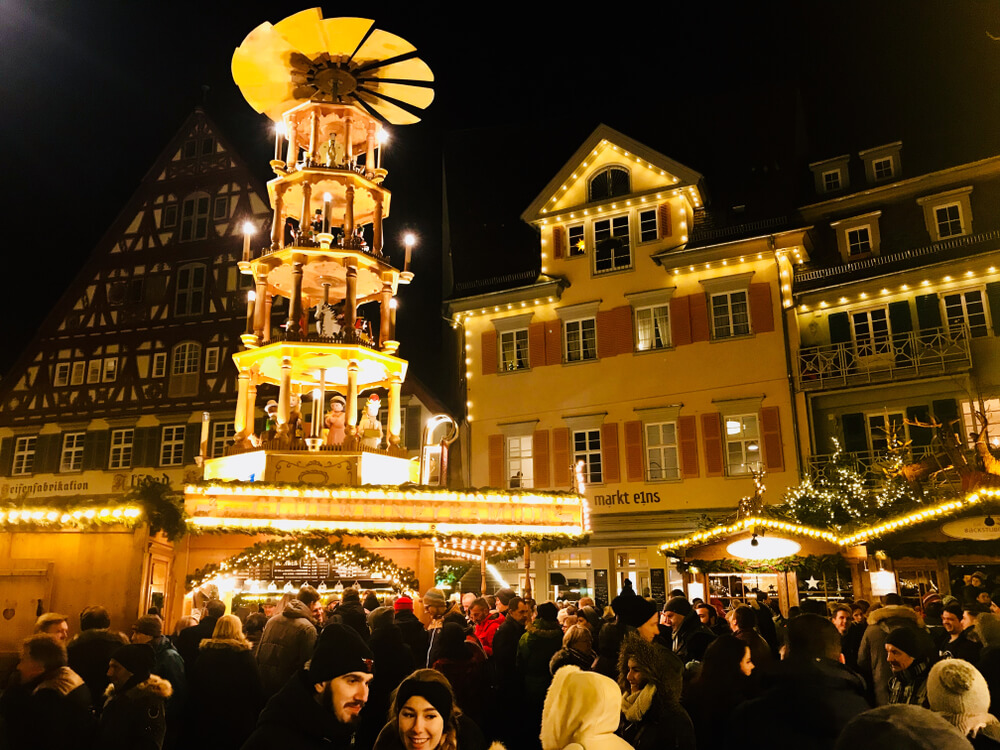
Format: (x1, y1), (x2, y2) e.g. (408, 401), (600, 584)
(521, 124), (704, 224)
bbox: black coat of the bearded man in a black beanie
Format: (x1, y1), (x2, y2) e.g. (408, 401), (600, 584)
(242, 669), (363, 750)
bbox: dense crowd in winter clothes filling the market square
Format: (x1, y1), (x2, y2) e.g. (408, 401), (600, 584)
(0, 585), (1000, 750)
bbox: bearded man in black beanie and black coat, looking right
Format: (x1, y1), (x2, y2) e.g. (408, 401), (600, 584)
(243, 623), (375, 750)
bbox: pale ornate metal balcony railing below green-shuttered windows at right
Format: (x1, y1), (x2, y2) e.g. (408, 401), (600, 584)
(795, 326), (972, 391)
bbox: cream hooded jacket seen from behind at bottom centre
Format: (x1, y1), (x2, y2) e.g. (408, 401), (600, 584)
(541, 666), (632, 750)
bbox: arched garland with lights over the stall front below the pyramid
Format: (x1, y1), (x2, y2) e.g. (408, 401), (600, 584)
(188, 537), (415, 590)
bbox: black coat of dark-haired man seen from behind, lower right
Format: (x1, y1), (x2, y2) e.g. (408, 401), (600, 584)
(720, 658), (871, 750)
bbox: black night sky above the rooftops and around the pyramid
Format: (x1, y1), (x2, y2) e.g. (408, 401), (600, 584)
(0, 0), (1000, 400)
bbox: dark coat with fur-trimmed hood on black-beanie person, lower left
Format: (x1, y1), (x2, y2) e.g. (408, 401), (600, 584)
(95, 674), (172, 750)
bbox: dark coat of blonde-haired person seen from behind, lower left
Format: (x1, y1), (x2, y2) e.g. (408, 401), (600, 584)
(189, 638), (264, 750)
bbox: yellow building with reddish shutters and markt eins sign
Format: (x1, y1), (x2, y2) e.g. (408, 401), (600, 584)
(446, 126), (807, 601)
